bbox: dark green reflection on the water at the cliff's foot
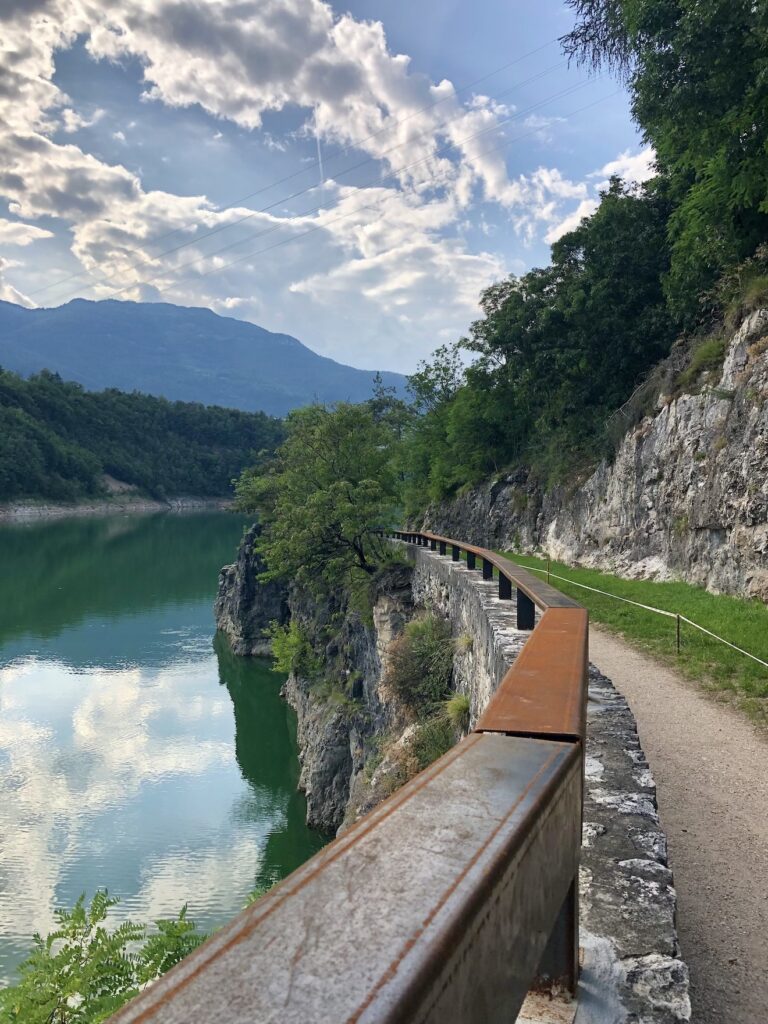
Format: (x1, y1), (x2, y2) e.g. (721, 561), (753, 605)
(214, 634), (331, 886)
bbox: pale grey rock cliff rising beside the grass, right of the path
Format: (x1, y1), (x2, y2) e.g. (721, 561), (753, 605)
(426, 310), (768, 600)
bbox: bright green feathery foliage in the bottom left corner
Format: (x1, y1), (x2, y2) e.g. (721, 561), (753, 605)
(0, 889), (206, 1024)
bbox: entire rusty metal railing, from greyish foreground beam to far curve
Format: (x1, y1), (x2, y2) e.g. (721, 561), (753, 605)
(112, 531), (588, 1024)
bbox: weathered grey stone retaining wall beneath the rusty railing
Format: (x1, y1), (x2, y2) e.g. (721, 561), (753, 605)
(410, 547), (690, 1024)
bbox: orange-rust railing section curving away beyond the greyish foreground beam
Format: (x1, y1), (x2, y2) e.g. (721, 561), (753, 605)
(393, 530), (589, 741)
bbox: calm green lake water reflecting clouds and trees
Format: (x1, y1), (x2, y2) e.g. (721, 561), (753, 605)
(0, 512), (327, 981)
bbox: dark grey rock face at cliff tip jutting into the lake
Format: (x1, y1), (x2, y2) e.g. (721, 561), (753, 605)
(213, 525), (288, 654)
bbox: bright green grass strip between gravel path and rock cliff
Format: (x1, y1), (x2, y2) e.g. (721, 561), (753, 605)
(502, 552), (768, 726)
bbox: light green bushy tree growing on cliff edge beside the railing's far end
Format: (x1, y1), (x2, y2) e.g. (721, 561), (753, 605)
(237, 403), (397, 588)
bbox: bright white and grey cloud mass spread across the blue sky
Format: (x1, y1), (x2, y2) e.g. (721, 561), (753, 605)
(0, 0), (606, 368)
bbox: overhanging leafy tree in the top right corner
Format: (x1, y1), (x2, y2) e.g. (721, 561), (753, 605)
(563, 0), (768, 321)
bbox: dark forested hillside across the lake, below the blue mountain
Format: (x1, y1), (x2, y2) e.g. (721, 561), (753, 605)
(0, 371), (282, 502)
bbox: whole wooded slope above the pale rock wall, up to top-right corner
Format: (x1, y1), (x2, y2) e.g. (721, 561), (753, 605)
(391, 0), (768, 513)
